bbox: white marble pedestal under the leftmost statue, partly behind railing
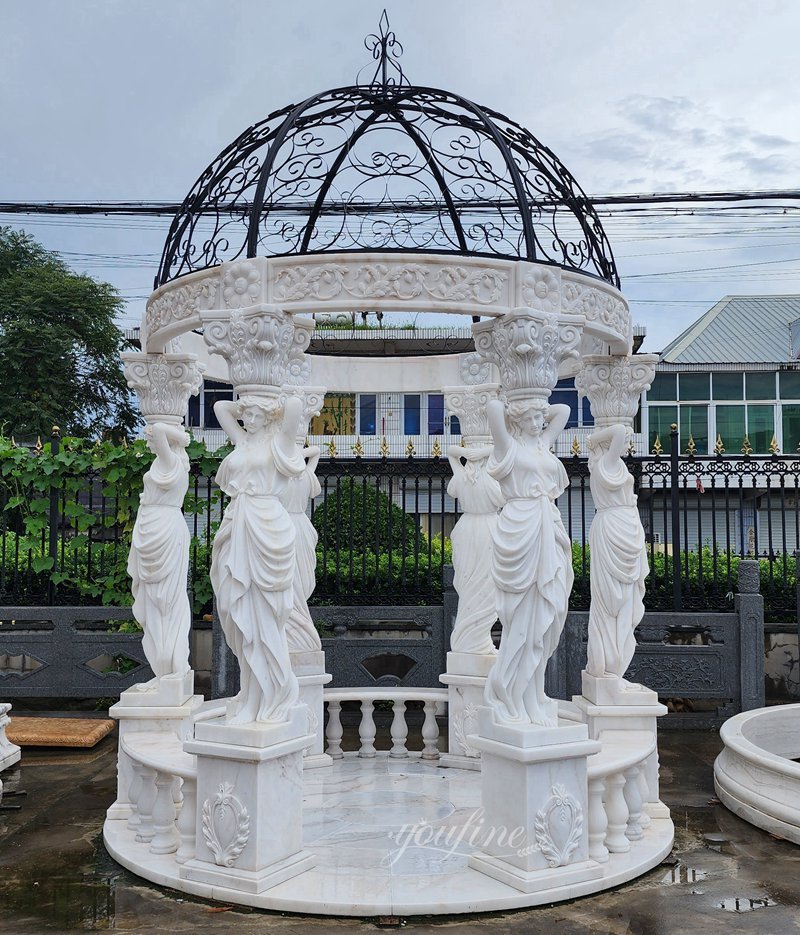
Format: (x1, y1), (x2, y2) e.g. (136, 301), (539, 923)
(107, 670), (203, 818)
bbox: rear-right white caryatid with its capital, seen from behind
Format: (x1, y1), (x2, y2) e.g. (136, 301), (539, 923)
(444, 383), (504, 656)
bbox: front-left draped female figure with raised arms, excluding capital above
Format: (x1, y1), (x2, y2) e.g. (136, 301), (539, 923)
(211, 395), (305, 724)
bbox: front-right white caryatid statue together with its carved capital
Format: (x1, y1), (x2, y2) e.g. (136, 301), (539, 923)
(473, 309), (583, 727)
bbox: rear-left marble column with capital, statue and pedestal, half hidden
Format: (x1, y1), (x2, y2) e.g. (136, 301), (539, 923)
(282, 380), (333, 769)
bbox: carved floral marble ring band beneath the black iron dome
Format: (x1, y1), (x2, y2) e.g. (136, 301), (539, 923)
(143, 253), (632, 354)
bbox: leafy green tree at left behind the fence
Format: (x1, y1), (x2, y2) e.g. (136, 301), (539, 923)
(0, 227), (138, 438)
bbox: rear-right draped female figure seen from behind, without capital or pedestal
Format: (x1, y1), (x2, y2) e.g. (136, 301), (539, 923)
(447, 445), (503, 656)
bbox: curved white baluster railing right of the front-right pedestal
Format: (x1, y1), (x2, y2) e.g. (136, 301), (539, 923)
(587, 730), (656, 863)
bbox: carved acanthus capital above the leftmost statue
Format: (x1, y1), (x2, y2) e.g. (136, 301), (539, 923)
(121, 352), (205, 424)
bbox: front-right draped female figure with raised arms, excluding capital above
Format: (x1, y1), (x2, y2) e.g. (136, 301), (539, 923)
(486, 397), (574, 727)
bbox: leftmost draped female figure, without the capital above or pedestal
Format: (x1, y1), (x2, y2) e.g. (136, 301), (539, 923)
(128, 422), (192, 690)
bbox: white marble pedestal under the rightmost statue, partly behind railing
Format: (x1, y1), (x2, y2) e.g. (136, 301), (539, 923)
(572, 672), (669, 818)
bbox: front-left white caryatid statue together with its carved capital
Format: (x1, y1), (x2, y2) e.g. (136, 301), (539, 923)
(202, 305), (313, 724)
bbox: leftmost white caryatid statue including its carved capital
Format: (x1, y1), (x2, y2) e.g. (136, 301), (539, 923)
(122, 353), (202, 691)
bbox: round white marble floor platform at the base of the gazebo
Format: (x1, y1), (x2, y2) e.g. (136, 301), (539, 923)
(104, 753), (674, 916)
